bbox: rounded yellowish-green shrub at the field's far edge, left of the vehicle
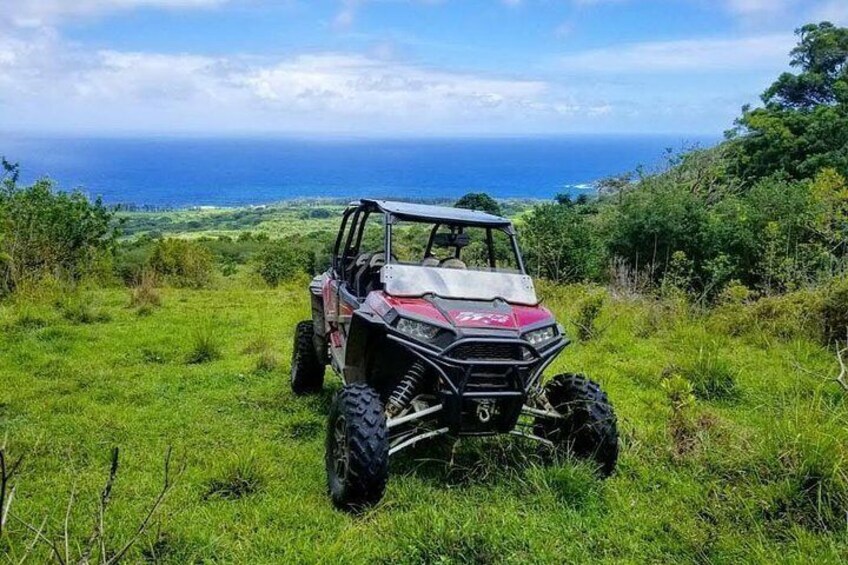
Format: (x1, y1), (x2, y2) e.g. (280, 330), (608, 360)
(147, 239), (214, 288)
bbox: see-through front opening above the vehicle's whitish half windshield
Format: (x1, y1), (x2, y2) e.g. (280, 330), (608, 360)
(391, 220), (521, 273)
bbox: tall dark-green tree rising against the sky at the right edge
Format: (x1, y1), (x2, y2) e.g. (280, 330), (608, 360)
(728, 22), (848, 183)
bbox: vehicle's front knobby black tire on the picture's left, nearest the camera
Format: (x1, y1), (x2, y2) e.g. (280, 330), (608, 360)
(325, 384), (389, 511)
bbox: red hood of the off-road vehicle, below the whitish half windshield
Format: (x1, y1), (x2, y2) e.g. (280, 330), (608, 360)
(369, 293), (555, 330)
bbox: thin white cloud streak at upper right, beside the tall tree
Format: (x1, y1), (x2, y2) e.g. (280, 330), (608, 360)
(558, 34), (795, 74)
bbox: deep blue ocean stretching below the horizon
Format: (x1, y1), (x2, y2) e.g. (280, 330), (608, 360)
(0, 135), (719, 208)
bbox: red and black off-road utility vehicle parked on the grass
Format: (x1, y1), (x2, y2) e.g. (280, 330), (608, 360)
(291, 200), (618, 509)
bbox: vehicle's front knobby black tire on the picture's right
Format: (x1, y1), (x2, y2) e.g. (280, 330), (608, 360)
(535, 374), (618, 477)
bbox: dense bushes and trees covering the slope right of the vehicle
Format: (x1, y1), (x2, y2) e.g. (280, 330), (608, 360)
(523, 23), (848, 299)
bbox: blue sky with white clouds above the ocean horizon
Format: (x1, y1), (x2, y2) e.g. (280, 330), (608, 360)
(0, 0), (848, 136)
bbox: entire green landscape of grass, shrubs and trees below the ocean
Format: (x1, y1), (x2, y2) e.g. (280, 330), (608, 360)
(0, 19), (848, 563)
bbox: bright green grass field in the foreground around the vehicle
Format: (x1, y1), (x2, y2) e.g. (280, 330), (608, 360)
(0, 282), (848, 563)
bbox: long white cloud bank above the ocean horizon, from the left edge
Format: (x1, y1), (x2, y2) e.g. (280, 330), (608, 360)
(0, 32), (611, 133)
